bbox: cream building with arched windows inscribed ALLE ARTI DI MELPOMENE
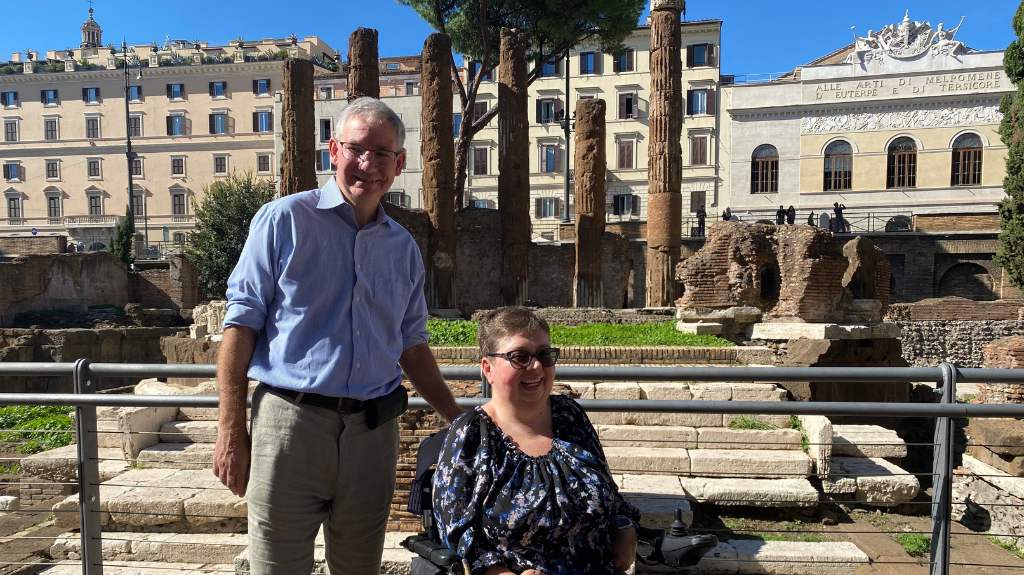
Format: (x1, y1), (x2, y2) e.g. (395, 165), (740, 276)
(722, 11), (1014, 231)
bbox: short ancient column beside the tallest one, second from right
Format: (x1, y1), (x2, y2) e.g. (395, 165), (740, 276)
(572, 98), (607, 308)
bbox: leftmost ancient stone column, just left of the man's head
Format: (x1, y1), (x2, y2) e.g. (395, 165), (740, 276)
(280, 58), (316, 195)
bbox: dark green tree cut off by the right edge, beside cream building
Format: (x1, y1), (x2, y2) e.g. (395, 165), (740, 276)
(995, 2), (1024, 289)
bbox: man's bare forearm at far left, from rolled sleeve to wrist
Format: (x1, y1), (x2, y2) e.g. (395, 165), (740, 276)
(217, 325), (256, 431)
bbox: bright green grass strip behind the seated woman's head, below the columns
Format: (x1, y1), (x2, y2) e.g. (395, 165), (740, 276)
(427, 319), (733, 347)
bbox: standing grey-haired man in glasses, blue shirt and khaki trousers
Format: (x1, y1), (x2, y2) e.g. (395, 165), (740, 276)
(213, 98), (459, 575)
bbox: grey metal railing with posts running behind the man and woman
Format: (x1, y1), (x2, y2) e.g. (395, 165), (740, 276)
(0, 359), (1024, 575)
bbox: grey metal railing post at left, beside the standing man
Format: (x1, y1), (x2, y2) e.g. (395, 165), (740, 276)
(74, 359), (103, 575)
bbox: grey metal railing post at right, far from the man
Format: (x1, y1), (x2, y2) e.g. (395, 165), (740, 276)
(930, 362), (956, 575)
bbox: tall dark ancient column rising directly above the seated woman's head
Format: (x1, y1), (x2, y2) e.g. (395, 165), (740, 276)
(498, 29), (530, 305)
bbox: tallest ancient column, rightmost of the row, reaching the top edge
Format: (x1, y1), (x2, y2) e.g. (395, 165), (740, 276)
(646, 0), (683, 307)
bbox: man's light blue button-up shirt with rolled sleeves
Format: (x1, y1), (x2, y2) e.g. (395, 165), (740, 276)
(224, 178), (427, 399)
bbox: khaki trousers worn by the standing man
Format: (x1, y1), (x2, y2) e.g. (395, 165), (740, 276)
(246, 386), (398, 575)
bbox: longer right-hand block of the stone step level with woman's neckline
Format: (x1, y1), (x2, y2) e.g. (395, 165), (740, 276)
(689, 449), (811, 478)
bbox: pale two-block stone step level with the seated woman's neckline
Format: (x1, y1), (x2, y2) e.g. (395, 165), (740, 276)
(605, 447), (812, 478)
